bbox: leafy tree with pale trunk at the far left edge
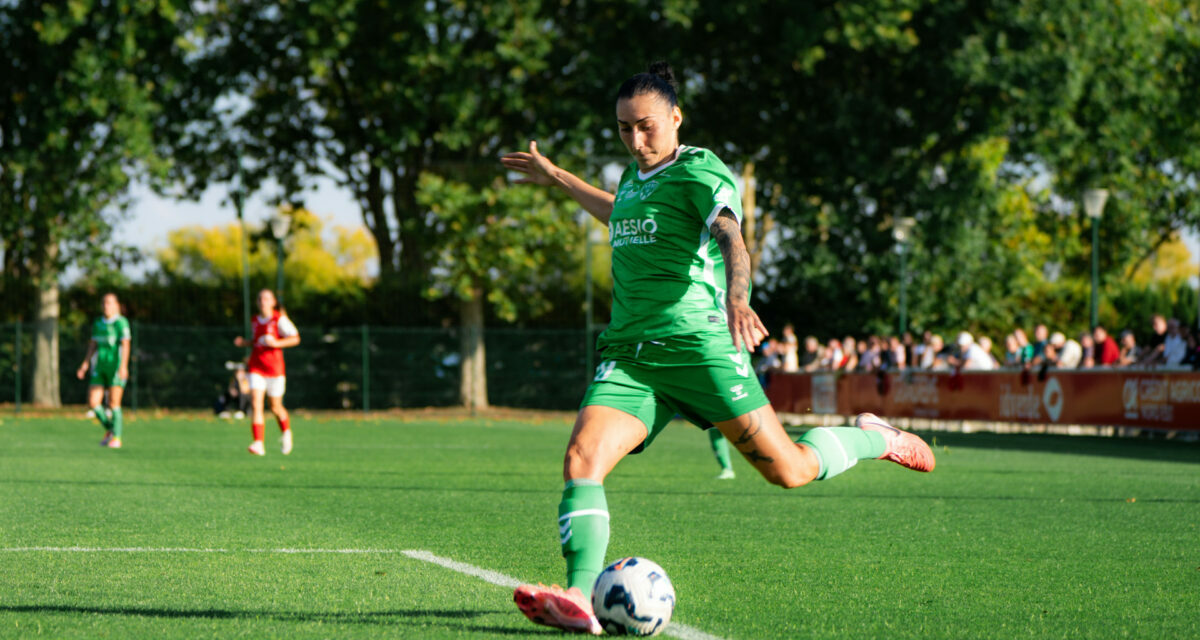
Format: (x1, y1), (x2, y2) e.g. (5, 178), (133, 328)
(0, 0), (188, 406)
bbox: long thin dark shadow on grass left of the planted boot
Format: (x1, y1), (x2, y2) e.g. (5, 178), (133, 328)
(0, 604), (557, 635)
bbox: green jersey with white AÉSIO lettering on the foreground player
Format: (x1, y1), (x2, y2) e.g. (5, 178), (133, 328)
(599, 145), (742, 348)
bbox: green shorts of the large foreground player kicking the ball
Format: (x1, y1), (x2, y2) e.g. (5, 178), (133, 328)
(581, 333), (768, 453)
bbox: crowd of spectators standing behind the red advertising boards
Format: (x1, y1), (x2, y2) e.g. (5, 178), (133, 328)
(758, 315), (1200, 373)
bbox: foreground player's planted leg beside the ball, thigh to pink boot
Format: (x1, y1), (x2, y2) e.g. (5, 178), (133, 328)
(512, 405), (647, 635)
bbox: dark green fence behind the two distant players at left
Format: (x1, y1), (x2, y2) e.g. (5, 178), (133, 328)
(0, 322), (595, 411)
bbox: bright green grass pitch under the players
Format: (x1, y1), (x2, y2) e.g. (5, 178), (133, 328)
(0, 413), (1200, 640)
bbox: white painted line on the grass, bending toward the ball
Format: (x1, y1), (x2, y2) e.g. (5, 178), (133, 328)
(0, 546), (725, 640)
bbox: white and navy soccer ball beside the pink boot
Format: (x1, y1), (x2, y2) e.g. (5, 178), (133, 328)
(592, 557), (674, 635)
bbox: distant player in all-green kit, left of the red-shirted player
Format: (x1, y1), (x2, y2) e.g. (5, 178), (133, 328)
(76, 293), (132, 449)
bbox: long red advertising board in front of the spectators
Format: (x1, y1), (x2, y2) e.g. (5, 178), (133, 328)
(768, 370), (1200, 430)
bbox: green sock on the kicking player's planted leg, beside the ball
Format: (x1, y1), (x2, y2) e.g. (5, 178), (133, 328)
(558, 479), (608, 598)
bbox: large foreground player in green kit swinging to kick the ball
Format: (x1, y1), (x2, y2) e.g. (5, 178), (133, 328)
(500, 62), (934, 634)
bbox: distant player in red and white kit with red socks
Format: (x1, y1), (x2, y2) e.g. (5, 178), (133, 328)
(233, 289), (300, 455)
